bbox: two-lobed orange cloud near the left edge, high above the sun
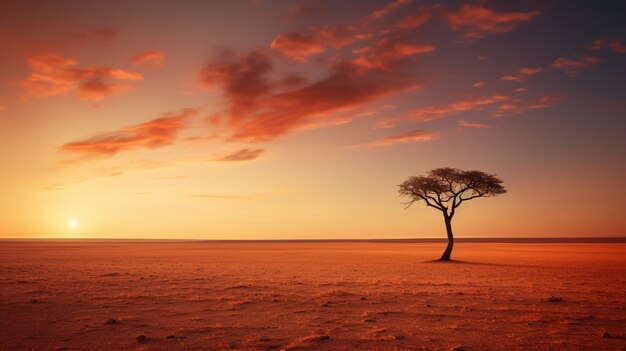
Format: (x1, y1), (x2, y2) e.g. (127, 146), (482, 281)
(19, 53), (143, 101)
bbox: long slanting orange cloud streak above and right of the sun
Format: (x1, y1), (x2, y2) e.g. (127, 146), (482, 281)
(61, 109), (197, 157)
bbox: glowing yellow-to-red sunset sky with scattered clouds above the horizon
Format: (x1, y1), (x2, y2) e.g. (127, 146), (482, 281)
(0, 0), (626, 239)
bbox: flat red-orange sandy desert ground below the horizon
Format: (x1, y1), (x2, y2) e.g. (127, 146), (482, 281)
(0, 241), (626, 350)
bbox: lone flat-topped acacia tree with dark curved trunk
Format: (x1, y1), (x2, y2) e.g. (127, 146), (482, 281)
(398, 168), (506, 261)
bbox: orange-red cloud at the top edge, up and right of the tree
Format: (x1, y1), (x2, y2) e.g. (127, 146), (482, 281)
(444, 4), (541, 40)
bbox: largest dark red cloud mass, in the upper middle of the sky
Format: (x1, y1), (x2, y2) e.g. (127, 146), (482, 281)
(199, 46), (418, 142)
